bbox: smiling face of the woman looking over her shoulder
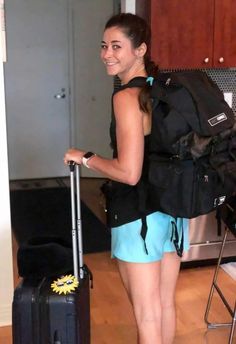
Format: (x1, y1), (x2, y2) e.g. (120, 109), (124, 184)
(101, 27), (140, 80)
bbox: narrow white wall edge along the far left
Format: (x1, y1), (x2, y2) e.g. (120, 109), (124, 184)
(0, 24), (13, 326)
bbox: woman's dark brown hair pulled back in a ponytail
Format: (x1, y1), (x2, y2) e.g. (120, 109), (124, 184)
(105, 13), (158, 112)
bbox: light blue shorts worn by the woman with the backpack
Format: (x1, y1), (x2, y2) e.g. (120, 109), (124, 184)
(111, 212), (189, 263)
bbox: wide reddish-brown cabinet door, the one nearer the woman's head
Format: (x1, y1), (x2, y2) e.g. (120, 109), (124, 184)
(150, 0), (215, 69)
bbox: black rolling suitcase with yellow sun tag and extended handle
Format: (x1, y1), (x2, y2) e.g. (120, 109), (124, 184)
(12, 165), (90, 344)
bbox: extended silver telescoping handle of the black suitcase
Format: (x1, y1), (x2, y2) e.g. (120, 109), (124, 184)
(69, 161), (84, 281)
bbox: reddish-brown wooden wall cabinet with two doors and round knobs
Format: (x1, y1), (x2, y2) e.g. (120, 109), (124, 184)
(136, 0), (236, 69)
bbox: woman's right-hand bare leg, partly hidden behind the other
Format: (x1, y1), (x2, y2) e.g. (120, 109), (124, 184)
(160, 252), (180, 344)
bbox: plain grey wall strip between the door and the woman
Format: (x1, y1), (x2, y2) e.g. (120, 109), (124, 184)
(73, 0), (113, 176)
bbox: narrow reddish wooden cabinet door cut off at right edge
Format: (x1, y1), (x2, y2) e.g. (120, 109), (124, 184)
(213, 0), (236, 68)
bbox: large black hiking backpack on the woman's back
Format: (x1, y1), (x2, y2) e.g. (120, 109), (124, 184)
(144, 71), (236, 218)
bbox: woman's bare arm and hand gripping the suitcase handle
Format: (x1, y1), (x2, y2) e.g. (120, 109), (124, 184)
(64, 88), (144, 185)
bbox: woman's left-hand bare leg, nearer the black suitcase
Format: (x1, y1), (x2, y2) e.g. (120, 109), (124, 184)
(118, 260), (163, 344)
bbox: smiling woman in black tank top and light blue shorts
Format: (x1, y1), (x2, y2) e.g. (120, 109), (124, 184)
(64, 13), (188, 344)
